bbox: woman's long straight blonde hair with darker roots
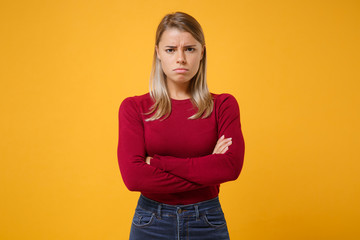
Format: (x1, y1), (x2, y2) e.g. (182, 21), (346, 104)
(144, 12), (214, 121)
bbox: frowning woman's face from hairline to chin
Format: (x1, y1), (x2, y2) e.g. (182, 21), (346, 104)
(156, 28), (204, 84)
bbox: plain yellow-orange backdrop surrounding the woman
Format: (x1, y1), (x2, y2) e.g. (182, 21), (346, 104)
(0, 0), (360, 240)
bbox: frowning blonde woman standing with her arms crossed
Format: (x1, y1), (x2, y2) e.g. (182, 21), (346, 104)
(118, 12), (244, 240)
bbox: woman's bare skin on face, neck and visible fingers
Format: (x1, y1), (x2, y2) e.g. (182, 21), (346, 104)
(146, 28), (232, 164)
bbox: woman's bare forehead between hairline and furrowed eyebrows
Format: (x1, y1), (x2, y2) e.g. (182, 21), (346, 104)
(159, 28), (201, 46)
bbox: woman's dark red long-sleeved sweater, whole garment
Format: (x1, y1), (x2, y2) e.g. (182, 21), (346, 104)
(117, 93), (244, 204)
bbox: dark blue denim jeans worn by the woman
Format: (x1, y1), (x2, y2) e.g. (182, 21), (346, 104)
(130, 195), (230, 240)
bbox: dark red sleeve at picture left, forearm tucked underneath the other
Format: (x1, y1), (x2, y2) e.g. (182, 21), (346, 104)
(117, 97), (204, 193)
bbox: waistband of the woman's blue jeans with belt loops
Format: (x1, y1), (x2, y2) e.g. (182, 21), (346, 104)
(138, 194), (221, 218)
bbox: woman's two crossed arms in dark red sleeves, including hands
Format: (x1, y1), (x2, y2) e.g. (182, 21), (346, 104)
(118, 94), (244, 193)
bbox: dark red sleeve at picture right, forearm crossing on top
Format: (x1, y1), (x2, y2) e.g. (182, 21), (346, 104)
(150, 94), (245, 185)
